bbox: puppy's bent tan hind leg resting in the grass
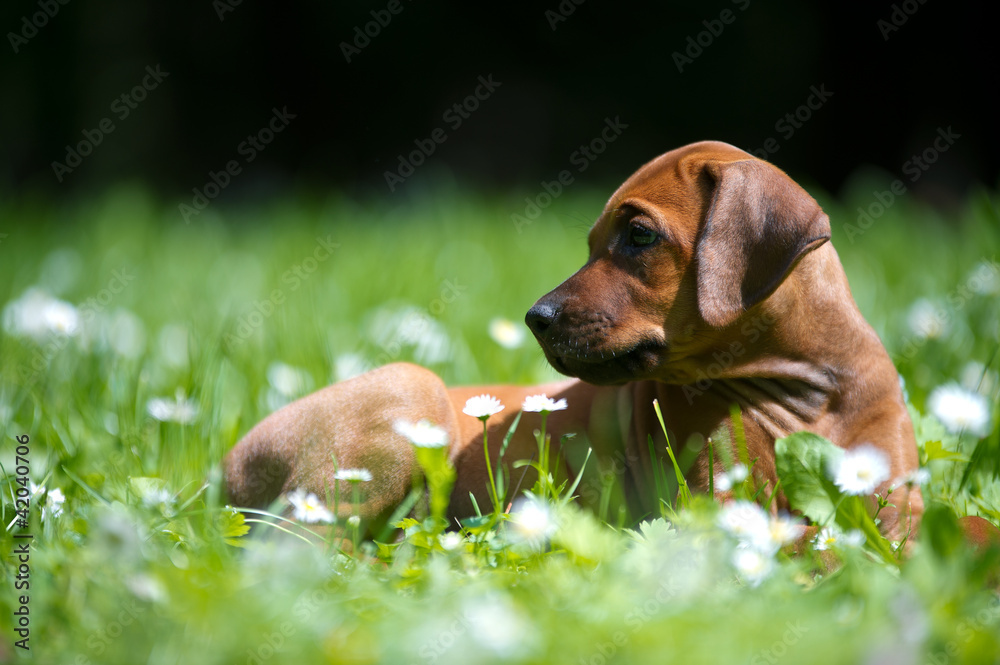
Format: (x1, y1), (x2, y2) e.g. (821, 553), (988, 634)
(224, 363), (458, 522)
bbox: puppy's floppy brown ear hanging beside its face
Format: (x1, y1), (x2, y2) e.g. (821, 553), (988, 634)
(695, 159), (830, 328)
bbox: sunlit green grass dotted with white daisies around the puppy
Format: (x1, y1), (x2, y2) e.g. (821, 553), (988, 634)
(0, 178), (1000, 665)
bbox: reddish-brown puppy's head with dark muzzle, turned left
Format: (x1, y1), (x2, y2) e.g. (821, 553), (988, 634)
(525, 141), (830, 384)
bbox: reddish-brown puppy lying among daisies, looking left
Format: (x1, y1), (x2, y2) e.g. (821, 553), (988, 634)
(225, 142), (923, 539)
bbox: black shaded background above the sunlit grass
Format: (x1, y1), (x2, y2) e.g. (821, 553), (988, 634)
(0, 0), (1000, 206)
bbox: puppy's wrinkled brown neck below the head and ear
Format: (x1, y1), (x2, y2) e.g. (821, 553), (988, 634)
(672, 244), (899, 438)
